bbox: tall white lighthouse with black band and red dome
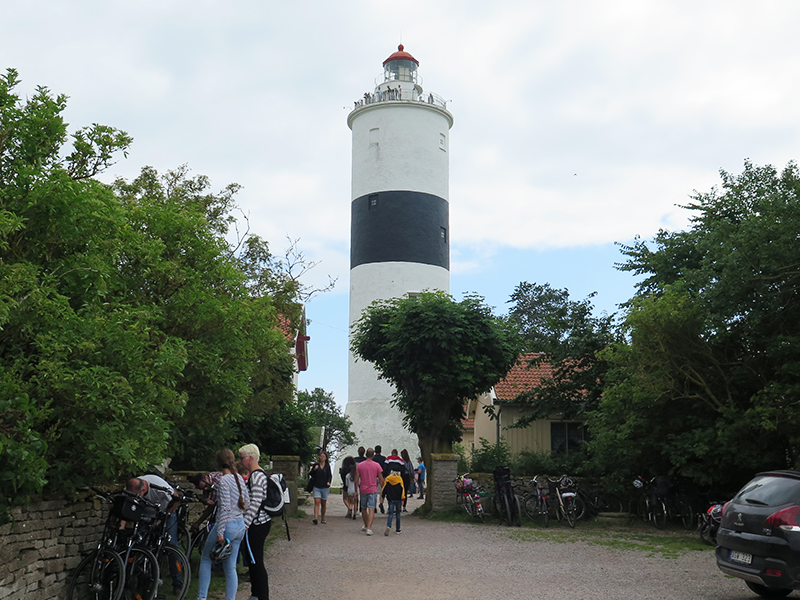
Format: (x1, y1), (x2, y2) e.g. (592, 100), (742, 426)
(345, 45), (453, 458)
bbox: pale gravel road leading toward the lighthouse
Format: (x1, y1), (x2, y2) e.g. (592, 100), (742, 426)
(236, 496), (757, 600)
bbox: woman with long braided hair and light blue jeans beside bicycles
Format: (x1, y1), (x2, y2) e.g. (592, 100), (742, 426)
(197, 448), (250, 600)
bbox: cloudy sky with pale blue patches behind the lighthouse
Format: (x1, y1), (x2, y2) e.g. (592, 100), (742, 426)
(6, 0), (800, 403)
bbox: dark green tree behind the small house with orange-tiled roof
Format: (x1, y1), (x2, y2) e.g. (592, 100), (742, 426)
(509, 282), (616, 427)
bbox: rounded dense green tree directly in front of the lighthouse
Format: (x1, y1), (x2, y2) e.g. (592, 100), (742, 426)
(351, 292), (519, 508)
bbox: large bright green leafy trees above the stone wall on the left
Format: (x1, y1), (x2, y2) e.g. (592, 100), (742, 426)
(0, 70), (299, 508)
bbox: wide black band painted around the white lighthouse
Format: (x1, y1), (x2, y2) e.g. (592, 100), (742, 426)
(350, 191), (450, 270)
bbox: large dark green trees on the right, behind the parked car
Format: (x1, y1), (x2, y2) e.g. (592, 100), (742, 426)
(591, 162), (800, 487)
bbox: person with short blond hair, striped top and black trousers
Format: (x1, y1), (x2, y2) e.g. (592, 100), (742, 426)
(239, 444), (272, 600)
